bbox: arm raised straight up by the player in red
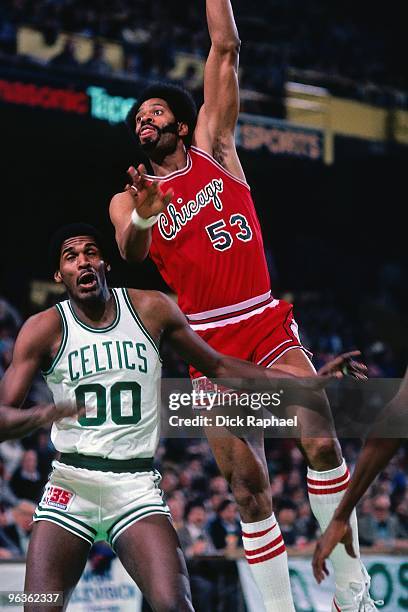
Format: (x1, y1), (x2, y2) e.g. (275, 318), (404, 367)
(193, 0), (245, 180)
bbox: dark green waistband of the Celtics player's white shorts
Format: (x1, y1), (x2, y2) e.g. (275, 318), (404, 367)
(57, 453), (153, 473)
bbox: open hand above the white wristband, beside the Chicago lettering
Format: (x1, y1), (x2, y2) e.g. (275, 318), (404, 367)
(125, 164), (174, 219)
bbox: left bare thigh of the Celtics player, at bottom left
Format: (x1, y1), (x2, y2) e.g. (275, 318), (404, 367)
(24, 521), (91, 612)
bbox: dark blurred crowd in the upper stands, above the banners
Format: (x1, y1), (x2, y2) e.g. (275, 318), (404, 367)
(0, 0), (408, 105)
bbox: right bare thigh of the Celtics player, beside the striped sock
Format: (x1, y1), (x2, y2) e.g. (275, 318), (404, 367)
(115, 515), (193, 612)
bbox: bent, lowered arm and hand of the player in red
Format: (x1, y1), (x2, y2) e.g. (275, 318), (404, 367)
(109, 164), (173, 262)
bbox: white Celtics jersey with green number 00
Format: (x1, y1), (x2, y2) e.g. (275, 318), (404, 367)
(43, 289), (161, 459)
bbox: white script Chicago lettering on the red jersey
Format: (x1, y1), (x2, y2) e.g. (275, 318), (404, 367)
(158, 178), (224, 240)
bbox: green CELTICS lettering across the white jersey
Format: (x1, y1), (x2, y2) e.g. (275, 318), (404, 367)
(68, 340), (147, 381)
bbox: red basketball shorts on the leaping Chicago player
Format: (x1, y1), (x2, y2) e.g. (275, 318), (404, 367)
(190, 300), (311, 380)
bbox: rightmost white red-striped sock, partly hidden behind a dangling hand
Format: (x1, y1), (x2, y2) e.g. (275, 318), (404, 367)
(307, 459), (364, 588)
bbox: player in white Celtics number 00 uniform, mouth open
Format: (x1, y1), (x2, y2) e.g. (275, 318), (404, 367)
(0, 224), (364, 612)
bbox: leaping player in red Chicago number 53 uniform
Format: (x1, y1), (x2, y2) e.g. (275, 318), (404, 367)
(110, 0), (375, 612)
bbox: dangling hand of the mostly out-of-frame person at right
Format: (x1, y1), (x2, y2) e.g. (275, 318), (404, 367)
(312, 518), (356, 584)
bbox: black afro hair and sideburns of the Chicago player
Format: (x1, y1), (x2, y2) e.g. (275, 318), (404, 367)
(125, 82), (197, 147)
